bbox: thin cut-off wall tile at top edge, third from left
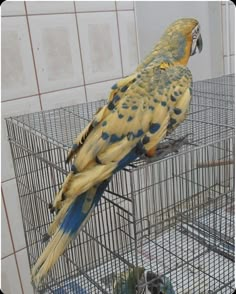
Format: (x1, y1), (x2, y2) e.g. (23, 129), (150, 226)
(75, 1), (116, 12)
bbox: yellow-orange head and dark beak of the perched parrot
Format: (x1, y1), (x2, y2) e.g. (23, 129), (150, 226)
(163, 18), (203, 64)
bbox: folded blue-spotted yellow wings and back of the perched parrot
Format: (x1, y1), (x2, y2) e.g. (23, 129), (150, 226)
(51, 66), (191, 218)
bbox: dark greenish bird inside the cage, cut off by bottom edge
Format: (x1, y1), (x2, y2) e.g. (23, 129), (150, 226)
(112, 267), (175, 294)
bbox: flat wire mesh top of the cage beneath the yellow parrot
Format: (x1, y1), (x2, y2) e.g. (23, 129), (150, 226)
(6, 74), (235, 156)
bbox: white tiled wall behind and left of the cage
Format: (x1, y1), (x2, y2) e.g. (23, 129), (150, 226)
(1, 1), (137, 294)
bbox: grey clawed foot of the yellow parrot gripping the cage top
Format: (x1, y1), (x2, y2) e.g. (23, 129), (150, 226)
(142, 134), (193, 163)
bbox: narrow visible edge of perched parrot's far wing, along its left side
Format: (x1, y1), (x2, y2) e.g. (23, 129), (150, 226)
(66, 73), (137, 163)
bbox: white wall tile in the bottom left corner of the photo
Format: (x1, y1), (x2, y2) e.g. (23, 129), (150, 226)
(1, 255), (23, 294)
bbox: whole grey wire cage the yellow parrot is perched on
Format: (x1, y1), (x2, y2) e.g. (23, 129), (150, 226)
(6, 75), (234, 294)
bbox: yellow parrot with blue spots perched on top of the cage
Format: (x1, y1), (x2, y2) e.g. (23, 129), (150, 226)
(31, 18), (203, 287)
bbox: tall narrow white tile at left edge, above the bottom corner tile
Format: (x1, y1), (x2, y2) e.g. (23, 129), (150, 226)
(2, 179), (26, 251)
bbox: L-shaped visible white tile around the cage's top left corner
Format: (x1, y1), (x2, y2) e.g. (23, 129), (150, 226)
(1, 96), (40, 181)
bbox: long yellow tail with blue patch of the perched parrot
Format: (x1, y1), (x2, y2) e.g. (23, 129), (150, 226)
(32, 179), (109, 287)
